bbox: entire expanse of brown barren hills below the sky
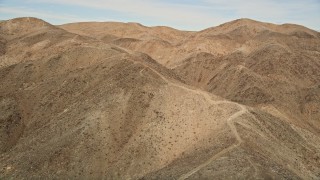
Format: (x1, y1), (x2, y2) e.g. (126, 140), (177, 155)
(0, 18), (320, 179)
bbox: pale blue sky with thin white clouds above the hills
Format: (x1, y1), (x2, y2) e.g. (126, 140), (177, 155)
(0, 0), (320, 31)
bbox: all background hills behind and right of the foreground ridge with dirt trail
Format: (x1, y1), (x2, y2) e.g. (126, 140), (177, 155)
(60, 19), (320, 132)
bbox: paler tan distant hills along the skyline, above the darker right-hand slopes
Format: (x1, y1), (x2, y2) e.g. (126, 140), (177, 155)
(59, 19), (320, 68)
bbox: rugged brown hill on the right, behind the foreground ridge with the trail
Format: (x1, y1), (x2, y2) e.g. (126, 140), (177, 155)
(172, 19), (320, 133)
